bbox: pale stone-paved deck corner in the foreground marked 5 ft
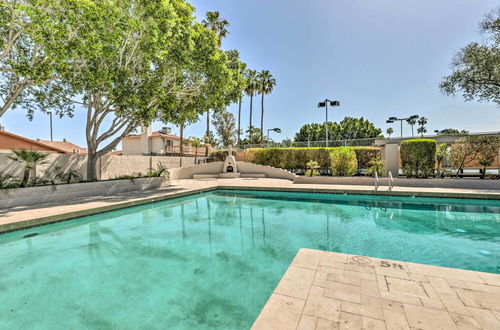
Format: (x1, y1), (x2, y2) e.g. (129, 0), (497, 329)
(252, 249), (500, 330)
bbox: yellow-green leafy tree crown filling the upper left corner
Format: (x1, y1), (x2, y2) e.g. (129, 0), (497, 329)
(0, 0), (88, 118)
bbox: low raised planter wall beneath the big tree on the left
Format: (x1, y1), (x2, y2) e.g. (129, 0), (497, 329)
(0, 177), (169, 208)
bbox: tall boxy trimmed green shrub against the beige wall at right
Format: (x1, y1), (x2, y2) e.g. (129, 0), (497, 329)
(400, 139), (436, 178)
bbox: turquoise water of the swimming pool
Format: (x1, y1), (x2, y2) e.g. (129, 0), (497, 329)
(0, 191), (500, 329)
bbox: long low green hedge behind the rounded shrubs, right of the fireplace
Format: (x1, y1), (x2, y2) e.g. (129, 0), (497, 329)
(245, 147), (381, 170)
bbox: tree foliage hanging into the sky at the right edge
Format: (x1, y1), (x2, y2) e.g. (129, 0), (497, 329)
(440, 7), (500, 105)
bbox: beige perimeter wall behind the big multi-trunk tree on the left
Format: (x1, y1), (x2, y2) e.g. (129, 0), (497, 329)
(0, 154), (194, 180)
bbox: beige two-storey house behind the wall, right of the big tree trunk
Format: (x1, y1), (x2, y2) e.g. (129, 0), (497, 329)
(122, 127), (205, 156)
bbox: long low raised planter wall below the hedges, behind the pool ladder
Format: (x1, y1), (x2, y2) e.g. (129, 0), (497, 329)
(293, 176), (500, 191)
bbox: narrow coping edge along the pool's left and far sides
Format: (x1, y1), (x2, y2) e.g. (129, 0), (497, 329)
(0, 181), (500, 234)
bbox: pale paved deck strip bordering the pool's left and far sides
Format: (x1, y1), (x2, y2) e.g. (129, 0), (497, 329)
(0, 178), (500, 233)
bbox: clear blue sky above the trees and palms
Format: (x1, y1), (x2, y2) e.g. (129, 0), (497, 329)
(1, 0), (500, 146)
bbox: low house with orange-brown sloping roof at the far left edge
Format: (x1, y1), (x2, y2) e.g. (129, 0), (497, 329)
(0, 130), (87, 154)
